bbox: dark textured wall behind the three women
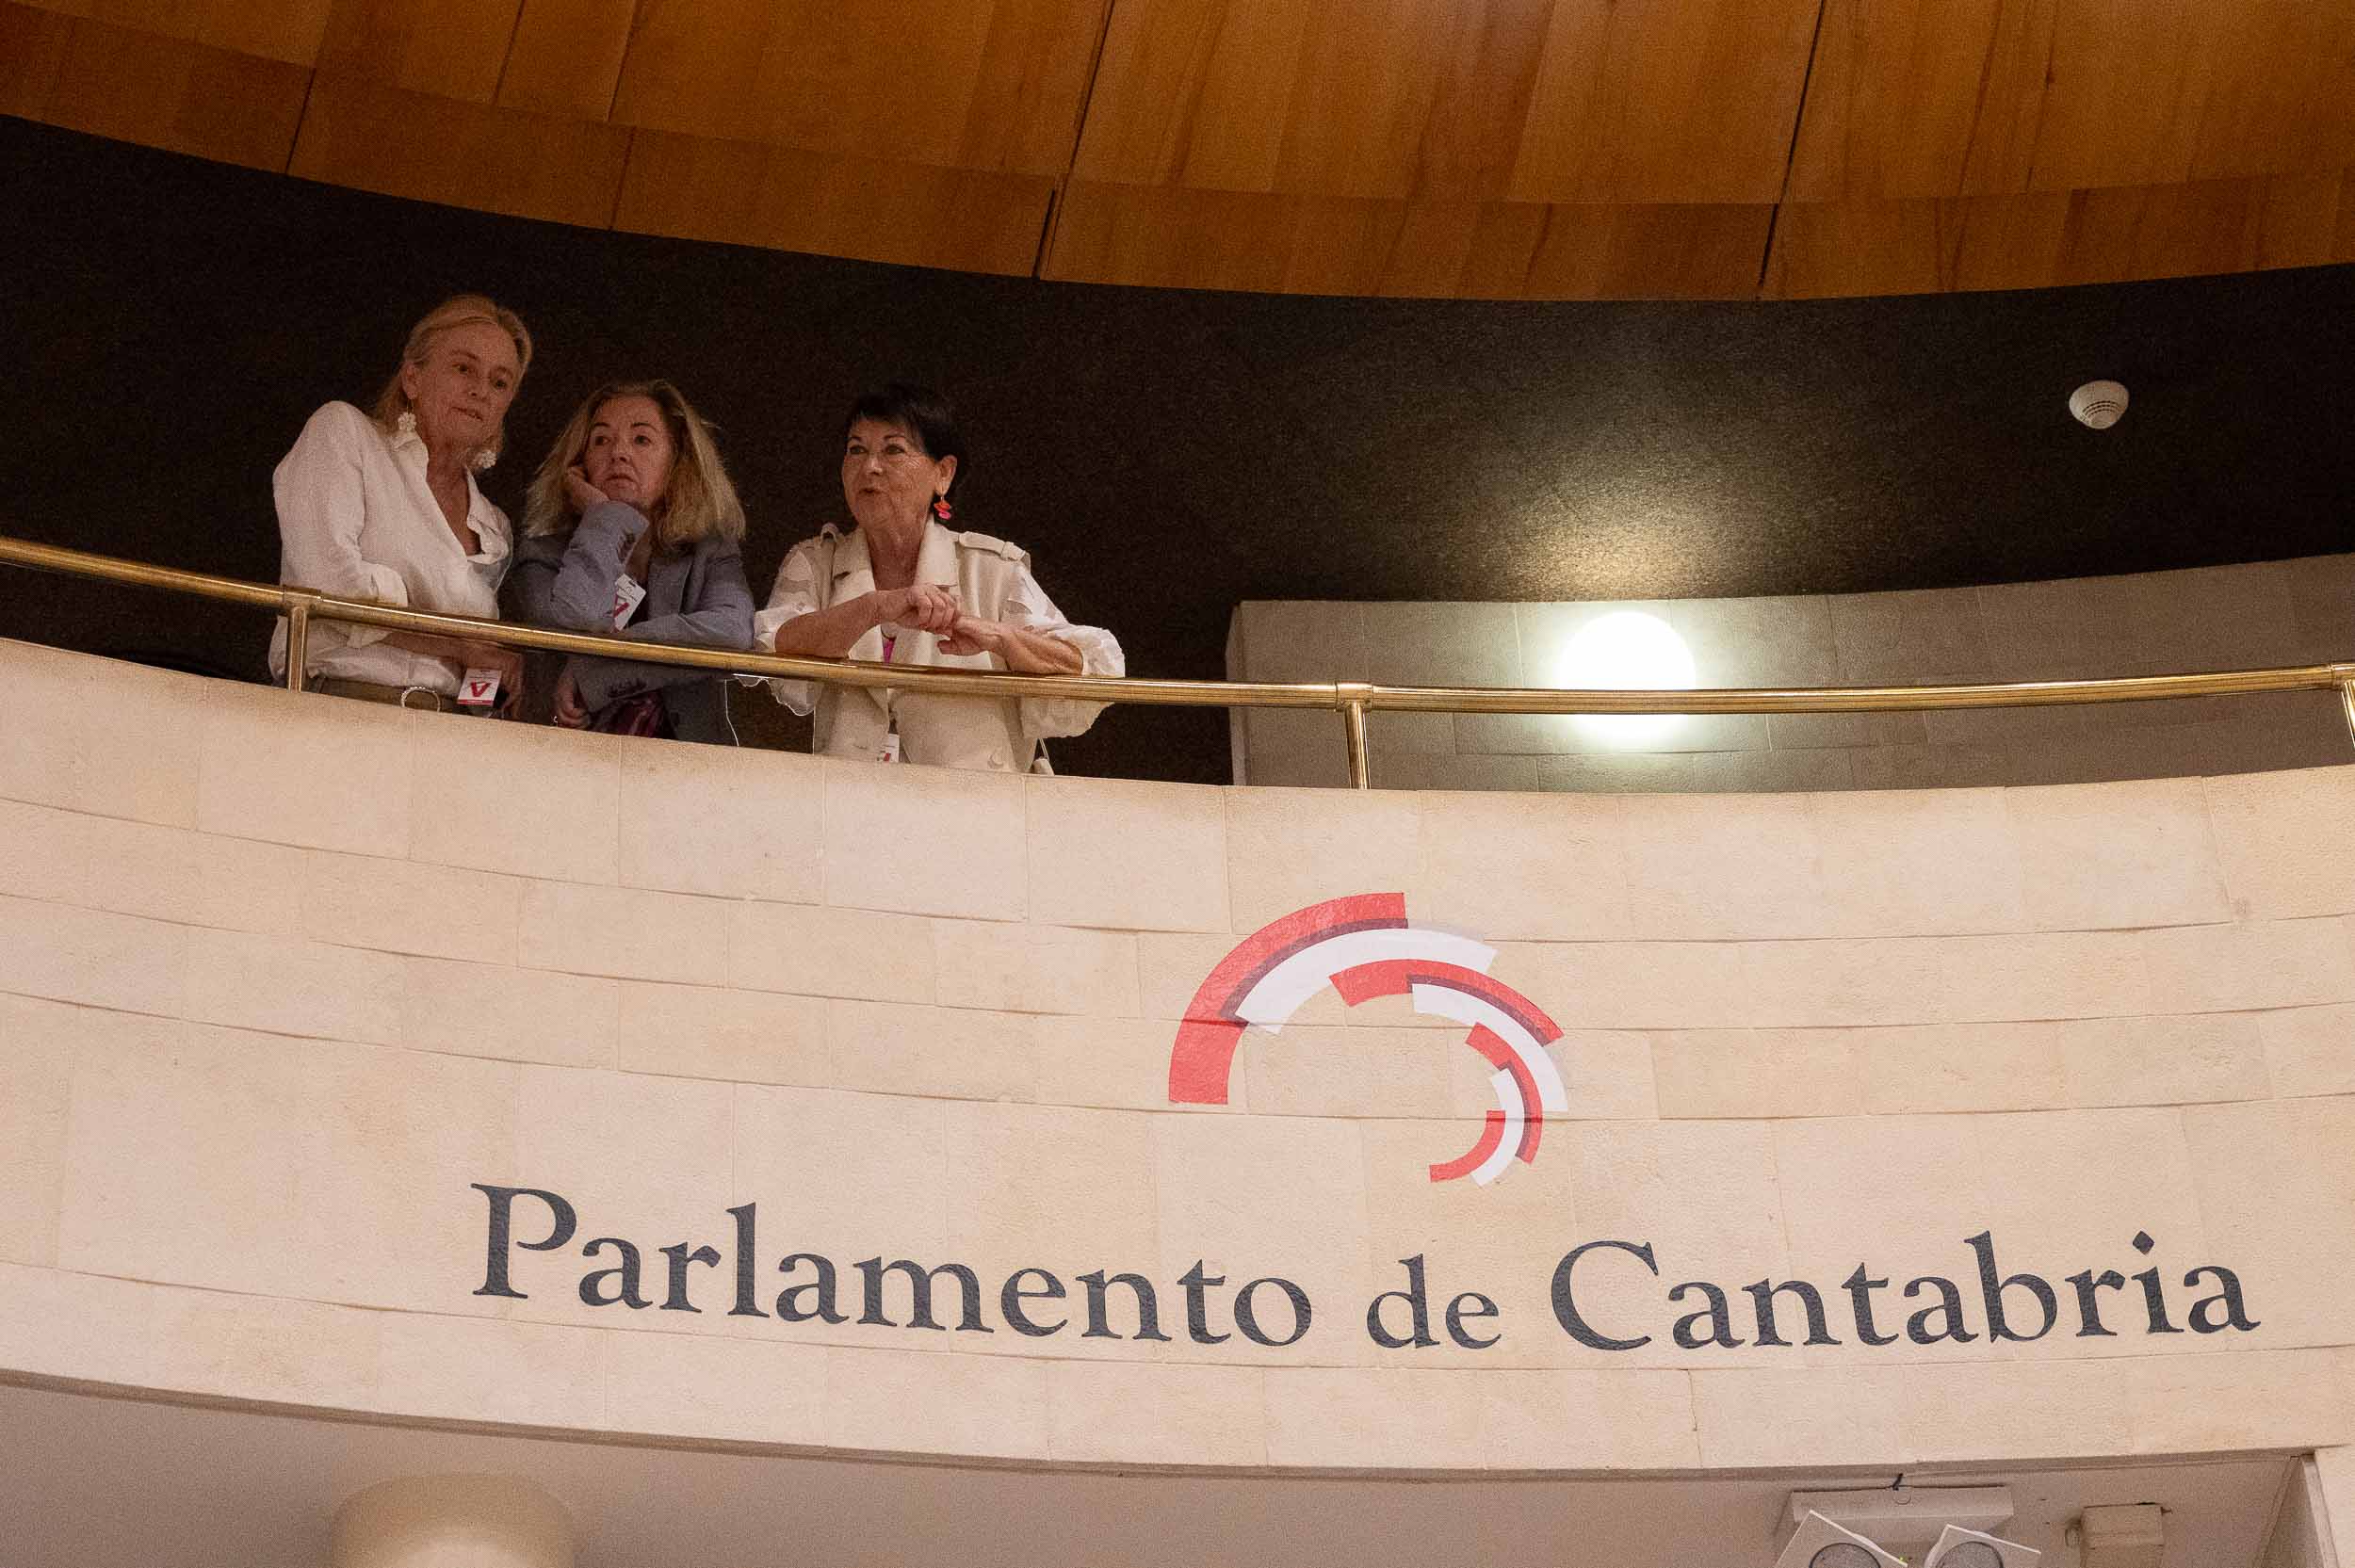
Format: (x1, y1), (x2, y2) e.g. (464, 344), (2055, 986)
(0, 118), (2355, 780)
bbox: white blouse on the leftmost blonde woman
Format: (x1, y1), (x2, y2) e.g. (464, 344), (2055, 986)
(271, 403), (513, 695)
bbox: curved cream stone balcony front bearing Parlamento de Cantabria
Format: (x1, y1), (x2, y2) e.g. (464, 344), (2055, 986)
(0, 645), (2355, 1474)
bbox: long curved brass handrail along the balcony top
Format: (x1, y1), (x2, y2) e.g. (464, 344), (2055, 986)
(0, 535), (2355, 789)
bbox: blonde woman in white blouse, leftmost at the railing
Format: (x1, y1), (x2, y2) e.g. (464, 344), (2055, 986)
(271, 295), (532, 709)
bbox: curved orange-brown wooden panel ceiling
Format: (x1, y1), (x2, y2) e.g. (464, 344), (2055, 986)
(0, 0), (2355, 299)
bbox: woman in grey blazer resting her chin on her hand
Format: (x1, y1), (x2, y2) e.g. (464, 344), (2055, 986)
(516, 381), (752, 747)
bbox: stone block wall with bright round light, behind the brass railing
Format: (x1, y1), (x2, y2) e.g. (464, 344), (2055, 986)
(1227, 556), (2355, 794)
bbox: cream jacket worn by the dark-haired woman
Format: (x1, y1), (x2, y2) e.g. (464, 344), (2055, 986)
(752, 523), (1126, 772)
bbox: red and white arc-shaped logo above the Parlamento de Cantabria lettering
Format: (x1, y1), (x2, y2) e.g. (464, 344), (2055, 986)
(1171, 893), (1571, 1187)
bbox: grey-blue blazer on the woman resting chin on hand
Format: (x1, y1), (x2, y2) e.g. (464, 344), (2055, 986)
(507, 502), (752, 747)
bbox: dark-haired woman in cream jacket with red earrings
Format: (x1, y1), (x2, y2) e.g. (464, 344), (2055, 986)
(754, 381), (1126, 772)
